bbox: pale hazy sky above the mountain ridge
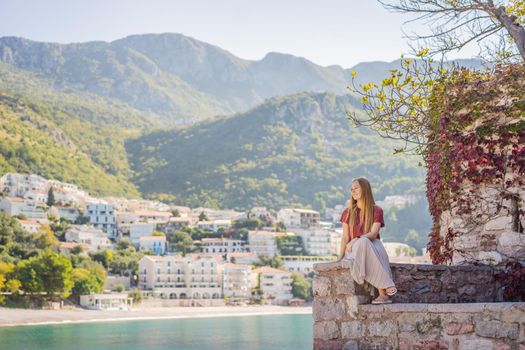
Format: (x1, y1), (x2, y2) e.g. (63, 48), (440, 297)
(0, 0), (475, 68)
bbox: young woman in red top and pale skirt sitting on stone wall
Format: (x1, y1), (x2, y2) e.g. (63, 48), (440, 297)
(339, 178), (397, 304)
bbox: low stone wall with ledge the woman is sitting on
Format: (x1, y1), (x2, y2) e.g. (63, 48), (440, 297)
(313, 262), (525, 350)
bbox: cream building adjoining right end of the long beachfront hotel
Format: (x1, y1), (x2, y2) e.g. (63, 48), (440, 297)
(222, 263), (251, 298)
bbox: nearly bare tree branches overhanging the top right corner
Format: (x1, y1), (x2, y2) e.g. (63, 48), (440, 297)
(379, 0), (525, 61)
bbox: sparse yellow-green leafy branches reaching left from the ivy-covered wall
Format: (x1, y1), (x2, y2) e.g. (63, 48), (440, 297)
(348, 50), (447, 154)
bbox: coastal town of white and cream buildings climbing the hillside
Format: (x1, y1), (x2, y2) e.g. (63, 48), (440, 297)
(0, 173), (425, 309)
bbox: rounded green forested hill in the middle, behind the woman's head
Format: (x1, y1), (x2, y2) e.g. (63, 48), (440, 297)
(126, 93), (424, 209)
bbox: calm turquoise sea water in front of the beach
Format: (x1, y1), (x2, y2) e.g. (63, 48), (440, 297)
(0, 315), (313, 350)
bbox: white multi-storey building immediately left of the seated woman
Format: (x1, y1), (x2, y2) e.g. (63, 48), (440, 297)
(294, 228), (341, 255)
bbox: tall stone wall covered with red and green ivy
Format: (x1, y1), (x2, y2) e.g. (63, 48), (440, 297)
(426, 64), (525, 266)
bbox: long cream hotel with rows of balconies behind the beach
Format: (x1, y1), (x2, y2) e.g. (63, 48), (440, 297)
(139, 255), (222, 299)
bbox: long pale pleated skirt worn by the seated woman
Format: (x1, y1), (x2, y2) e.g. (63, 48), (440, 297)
(343, 237), (394, 289)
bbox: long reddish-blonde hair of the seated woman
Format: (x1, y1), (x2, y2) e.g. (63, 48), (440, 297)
(348, 177), (376, 239)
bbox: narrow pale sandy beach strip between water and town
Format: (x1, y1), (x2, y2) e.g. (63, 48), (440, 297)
(0, 305), (312, 327)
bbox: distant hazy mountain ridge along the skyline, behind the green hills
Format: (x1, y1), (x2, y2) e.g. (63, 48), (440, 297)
(0, 34), (352, 125)
